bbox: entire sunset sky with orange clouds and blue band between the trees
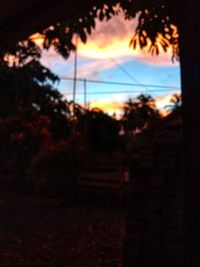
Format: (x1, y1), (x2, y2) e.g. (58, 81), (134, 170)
(38, 12), (180, 117)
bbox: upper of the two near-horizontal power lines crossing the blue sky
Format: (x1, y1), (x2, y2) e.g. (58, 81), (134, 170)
(60, 76), (180, 91)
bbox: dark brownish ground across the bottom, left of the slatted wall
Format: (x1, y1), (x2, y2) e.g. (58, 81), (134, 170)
(0, 195), (125, 267)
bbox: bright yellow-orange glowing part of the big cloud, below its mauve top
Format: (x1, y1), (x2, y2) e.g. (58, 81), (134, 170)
(78, 24), (172, 66)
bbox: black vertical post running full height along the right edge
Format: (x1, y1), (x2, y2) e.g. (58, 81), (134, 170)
(179, 0), (200, 267)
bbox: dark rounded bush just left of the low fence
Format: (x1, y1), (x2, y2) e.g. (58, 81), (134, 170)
(31, 134), (85, 197)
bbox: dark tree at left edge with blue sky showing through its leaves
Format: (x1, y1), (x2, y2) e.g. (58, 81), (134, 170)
(0, 60), (71, 138)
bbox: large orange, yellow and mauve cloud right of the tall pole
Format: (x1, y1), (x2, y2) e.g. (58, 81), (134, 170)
(78, 15), (177, 66)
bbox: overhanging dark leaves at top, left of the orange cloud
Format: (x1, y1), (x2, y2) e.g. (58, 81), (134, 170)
(36, 1), (118, 58)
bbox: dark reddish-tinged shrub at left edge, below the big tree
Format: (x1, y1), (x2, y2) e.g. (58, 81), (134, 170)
(0, 116), (50, 192)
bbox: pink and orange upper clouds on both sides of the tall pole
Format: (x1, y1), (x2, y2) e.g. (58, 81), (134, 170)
(34, 14), (177, 78)
